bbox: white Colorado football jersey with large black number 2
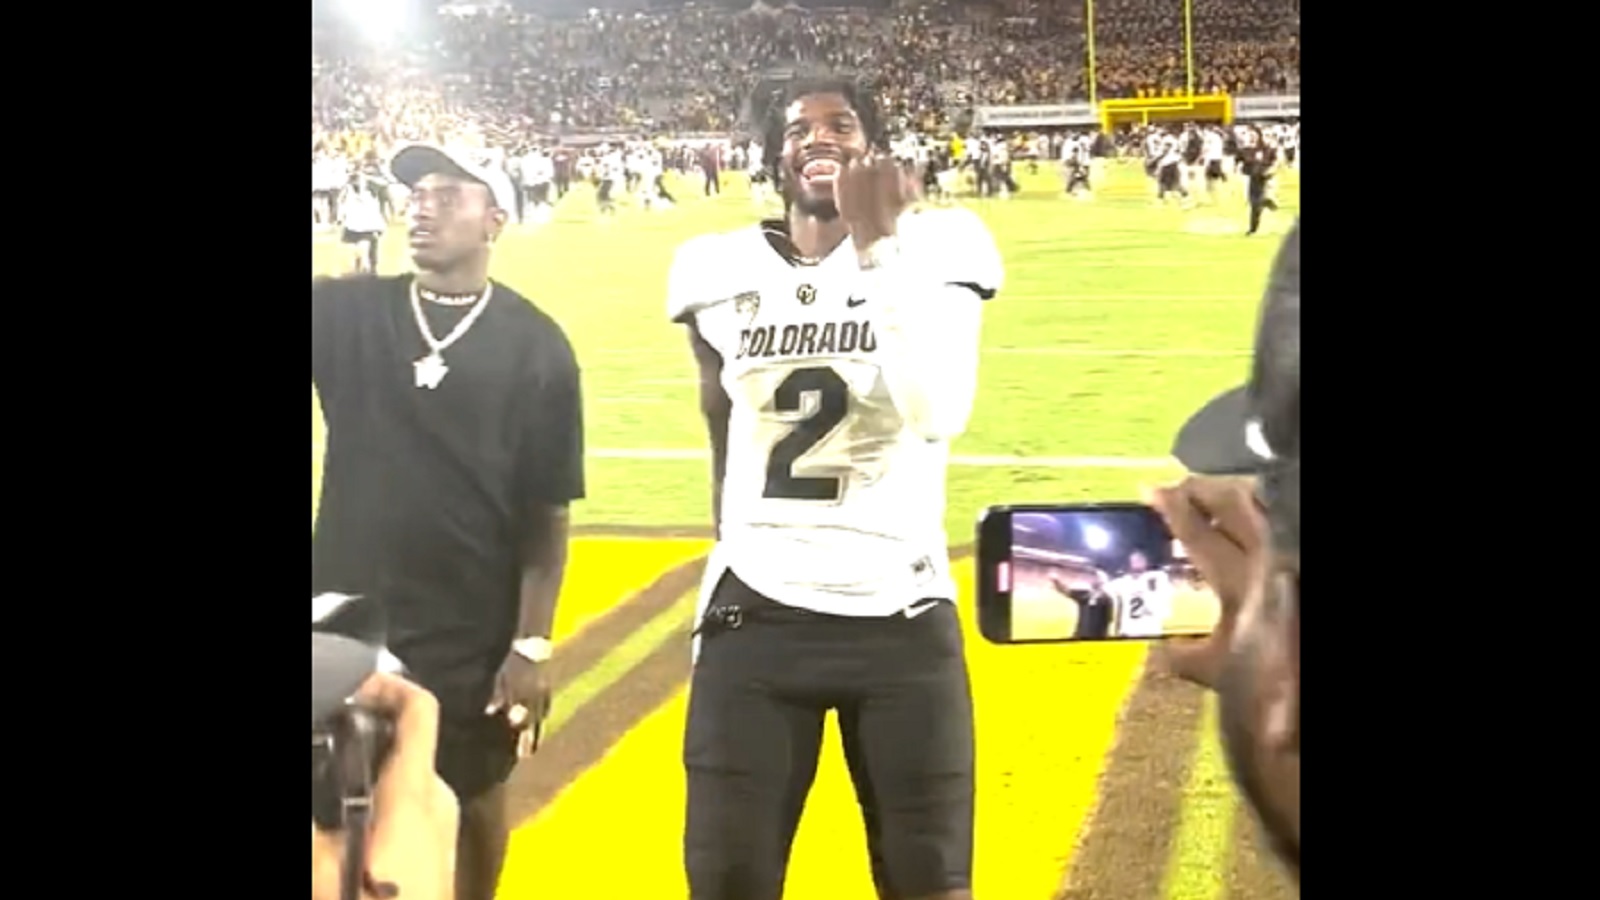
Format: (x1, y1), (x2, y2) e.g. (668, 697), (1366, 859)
(667, 208), (1003, 617)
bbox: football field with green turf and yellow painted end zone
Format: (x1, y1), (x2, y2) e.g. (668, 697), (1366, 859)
(312, 165), (1299, 900)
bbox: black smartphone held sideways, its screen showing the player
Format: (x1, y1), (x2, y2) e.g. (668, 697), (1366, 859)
(978, 503), (1221, 644)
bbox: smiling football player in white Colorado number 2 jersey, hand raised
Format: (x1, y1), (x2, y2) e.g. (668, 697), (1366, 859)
(667, 78), (1002, 900)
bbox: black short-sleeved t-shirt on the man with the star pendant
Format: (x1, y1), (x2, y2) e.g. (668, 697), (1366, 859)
(310, 275), (584, 711)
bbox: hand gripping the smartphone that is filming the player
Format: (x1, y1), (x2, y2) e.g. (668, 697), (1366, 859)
(1150, 477), (1267, 689)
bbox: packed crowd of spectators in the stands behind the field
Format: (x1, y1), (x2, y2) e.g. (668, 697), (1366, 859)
(312, 0), (1299, 149)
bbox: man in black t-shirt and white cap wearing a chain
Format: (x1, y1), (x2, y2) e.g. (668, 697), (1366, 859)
(312, 146), (584, 900)
